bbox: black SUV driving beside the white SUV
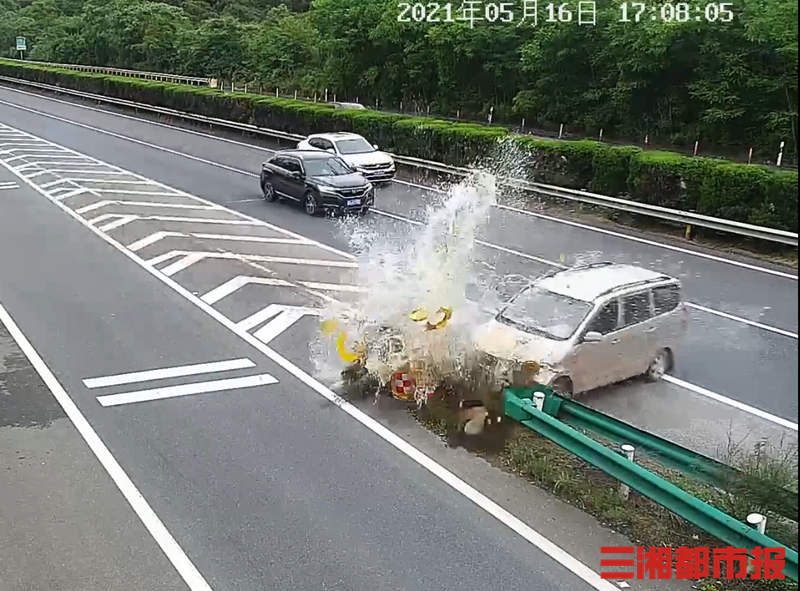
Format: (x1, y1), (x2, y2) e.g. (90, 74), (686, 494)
(261, 150), (375, 215)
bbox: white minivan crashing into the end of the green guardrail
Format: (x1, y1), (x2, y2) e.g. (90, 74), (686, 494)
(475, 263), (688, 395)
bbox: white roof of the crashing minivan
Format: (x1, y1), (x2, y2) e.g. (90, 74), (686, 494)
(538, 263), (673, 302)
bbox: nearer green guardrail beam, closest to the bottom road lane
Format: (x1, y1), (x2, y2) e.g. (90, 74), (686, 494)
(503, 389), (798, 582)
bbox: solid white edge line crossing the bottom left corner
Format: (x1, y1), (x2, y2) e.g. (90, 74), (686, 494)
(0, 302), (216, 591)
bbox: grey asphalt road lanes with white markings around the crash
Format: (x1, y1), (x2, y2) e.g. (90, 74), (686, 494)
(0, 83), (797, 591)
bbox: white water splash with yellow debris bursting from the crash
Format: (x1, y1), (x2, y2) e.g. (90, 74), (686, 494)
(312, 172), (497, 394)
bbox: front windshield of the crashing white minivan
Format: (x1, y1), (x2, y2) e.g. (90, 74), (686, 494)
(497, 286), (592, 341)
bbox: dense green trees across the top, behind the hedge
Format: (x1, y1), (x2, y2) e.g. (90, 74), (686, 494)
(0, 0), (798, 152)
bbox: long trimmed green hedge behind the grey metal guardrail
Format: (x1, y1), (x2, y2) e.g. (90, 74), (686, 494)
(0, 60), (798, 232)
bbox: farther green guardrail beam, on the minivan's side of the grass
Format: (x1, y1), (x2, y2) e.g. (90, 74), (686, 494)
(507, 386), (798, 520)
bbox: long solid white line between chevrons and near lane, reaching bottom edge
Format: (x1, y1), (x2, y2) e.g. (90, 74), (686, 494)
(0, 175), (617, 591)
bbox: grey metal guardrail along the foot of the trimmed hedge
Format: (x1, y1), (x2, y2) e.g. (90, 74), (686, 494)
(0, 71), (798, 247)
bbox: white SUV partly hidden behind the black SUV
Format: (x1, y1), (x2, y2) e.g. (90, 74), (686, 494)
(297, 132), (396, 183)
